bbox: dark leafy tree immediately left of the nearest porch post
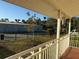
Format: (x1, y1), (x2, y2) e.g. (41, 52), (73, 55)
(46, 18), (57, 36)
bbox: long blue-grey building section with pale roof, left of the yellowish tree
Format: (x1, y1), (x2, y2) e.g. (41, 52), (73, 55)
(0, 22), (28, 33)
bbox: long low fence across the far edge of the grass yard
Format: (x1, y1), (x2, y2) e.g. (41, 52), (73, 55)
(0, 32), (55, 40)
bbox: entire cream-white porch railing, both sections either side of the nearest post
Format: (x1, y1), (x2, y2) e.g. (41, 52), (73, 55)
(5, 35), (69, 59)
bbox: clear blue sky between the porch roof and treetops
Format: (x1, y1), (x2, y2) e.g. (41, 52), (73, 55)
(0, 0), (47, 21)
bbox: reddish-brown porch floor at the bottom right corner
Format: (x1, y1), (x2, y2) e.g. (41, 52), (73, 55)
(60, 48), (79, 59)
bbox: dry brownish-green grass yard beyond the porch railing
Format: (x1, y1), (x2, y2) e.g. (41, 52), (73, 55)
(0, 35), (55, 59)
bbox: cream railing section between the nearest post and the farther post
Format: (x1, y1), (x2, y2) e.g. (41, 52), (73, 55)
(59, 35), (70, 57)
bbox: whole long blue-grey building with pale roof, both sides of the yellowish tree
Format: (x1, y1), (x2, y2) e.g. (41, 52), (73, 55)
(0, 22), (43, 33)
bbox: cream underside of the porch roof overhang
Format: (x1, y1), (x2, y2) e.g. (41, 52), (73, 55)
(3, 0), (79, 18)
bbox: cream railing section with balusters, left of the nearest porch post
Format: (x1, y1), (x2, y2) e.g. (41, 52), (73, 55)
(5, 40), (56, 59)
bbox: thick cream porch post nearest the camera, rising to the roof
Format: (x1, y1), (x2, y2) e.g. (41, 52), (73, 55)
(56, 10), (61, 59)
